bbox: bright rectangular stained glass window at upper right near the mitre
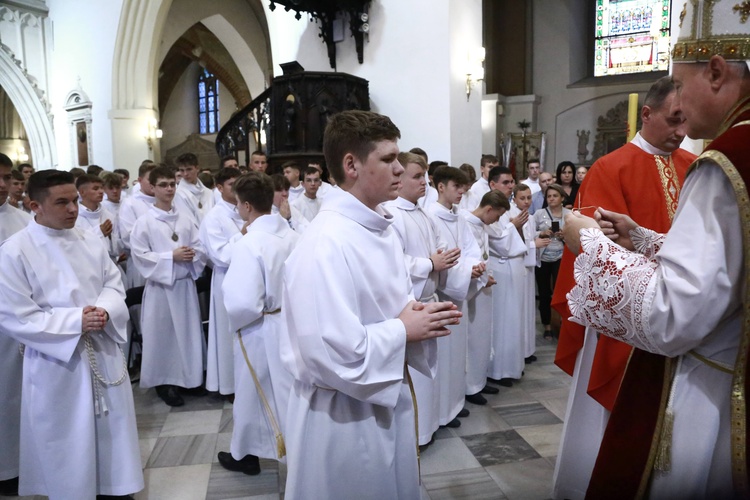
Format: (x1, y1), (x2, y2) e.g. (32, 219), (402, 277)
(594, 0), (671, 76)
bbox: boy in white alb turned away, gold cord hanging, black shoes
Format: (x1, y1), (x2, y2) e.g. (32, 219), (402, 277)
(219, 172), (299, 475)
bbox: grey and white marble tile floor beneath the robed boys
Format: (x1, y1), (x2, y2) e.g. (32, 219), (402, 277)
(0, 336), (570, 500)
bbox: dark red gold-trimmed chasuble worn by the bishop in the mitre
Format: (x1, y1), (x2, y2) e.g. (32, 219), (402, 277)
(586, 97), (750, 499)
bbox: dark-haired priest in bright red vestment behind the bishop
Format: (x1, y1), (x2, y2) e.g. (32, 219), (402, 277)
(553, 76), (695, 499)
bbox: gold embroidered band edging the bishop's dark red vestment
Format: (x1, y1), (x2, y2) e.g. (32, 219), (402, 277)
(698, 150), (750, 498)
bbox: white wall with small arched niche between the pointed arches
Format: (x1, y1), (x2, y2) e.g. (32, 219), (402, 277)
(47, 0), (124, 170)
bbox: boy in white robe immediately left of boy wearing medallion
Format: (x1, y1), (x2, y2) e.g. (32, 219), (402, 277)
(118, 162), (156, 289)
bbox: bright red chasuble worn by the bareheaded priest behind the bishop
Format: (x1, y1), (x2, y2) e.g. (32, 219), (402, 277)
(552, 143), (696, 411)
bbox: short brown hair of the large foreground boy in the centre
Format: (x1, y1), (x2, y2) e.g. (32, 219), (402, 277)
(323, 110), (401, 184)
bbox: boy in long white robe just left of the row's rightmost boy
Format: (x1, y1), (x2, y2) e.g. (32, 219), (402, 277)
(487, 167), (529, 387)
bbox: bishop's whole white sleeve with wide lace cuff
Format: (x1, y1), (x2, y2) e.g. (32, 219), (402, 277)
(568, 166), (743, 356)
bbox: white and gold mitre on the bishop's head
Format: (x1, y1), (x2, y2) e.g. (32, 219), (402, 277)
(672, 0), (750, 68)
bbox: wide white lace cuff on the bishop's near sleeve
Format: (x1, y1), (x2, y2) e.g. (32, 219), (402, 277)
(567, 229), (664, 354)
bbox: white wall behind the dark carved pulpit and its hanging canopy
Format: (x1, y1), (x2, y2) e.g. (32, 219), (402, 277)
(264, 0), (481, 166)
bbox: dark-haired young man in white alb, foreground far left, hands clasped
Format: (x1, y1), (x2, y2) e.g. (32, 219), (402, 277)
(0, 170), (143, 500)
